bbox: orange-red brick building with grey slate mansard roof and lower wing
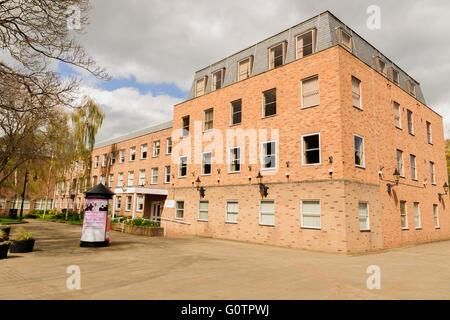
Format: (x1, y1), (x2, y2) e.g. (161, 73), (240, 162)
(51, 12), (450, 253)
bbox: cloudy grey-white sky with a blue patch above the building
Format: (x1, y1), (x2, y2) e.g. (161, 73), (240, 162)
(64, 0), (450, 141)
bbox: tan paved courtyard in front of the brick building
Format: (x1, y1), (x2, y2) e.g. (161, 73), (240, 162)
(0, 221), (450, 299)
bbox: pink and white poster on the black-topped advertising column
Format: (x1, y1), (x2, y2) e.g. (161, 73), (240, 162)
(81, 199), (108, 242)
